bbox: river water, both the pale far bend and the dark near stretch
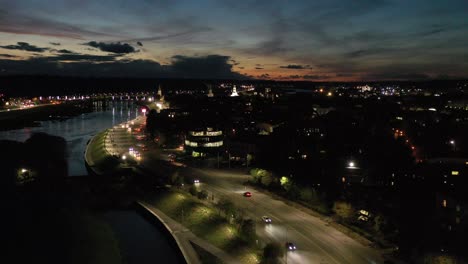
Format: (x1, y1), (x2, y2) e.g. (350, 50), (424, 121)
(0, 101), (183, 264)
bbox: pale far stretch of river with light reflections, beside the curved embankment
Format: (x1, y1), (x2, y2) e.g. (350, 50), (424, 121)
(0, 101), (141, 176)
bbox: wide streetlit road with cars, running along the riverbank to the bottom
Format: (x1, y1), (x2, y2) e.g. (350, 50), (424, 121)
(106, 119), (383, 264)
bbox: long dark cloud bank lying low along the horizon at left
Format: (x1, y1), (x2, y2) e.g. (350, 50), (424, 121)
(0, 53), (248, 79)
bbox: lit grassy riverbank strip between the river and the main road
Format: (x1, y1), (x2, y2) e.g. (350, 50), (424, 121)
(85, 119), (258, 263)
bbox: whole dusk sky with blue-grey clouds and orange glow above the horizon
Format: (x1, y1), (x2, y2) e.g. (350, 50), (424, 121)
(0, 0), (468, 81)
